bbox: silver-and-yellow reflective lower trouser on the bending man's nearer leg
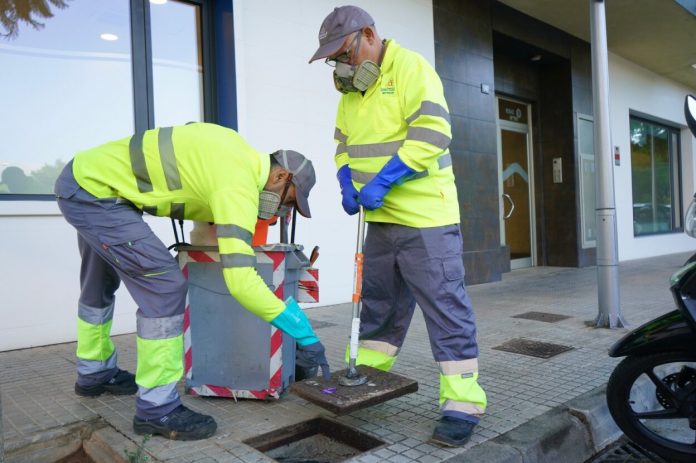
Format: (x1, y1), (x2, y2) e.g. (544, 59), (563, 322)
(135, 316), (184, 419)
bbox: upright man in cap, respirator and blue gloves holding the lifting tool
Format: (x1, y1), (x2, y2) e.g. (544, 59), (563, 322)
(310, 6), (486, 446)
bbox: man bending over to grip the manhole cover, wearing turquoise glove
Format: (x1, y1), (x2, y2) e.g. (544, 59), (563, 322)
(55, 123), (329, 440)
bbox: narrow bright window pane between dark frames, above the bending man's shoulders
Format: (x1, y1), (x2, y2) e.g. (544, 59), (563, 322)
(150, 1), (203, 127)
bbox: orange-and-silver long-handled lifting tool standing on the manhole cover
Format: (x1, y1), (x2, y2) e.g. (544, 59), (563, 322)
(338, 206), (367, 386)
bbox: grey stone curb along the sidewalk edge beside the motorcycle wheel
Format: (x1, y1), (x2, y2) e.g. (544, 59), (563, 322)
(445, 386), (622, 463)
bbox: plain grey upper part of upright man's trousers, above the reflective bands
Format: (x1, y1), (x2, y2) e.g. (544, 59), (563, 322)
(360, 222), (478, 362)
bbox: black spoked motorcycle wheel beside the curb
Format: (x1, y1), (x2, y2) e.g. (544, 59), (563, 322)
(607, 352), (696, 462)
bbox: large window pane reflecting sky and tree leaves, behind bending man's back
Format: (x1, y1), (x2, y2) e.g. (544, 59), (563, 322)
(0, 0), (134, 198)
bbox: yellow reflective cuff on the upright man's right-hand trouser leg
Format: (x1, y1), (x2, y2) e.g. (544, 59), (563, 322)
(438, 359), (486, 418)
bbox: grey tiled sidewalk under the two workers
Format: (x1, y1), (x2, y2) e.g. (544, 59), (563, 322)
(0, 254), (689, 463)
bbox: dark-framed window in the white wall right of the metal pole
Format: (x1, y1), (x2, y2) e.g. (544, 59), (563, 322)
(631, 116), (681, 236)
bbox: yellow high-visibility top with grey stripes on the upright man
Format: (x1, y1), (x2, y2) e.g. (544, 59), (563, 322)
(334, 40), (459, 228)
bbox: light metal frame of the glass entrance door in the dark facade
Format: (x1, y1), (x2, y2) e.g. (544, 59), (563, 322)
(495, 95), (537, 270)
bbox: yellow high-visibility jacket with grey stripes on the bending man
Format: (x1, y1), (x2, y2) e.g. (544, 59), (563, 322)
(73, 123), (285, 321)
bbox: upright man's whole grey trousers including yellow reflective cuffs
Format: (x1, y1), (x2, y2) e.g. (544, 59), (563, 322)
(358, 222), (486, 422)
